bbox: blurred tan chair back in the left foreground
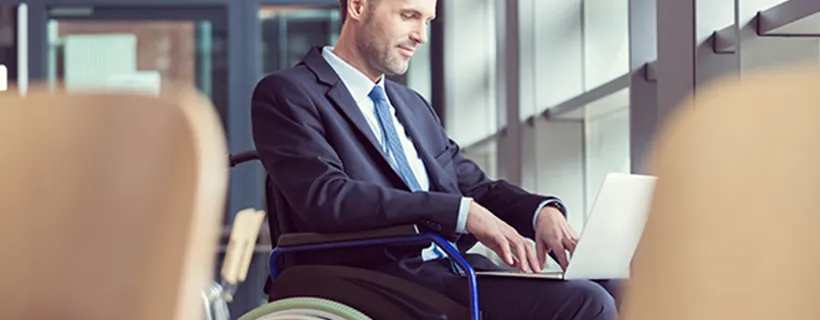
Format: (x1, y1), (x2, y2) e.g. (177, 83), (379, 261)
(0, 84), (228, 320)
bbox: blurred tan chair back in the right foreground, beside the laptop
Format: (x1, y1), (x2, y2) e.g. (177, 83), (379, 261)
(621, 66), (820, 320)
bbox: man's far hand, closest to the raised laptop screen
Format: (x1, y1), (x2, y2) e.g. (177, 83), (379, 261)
(535, 206), (578, 271)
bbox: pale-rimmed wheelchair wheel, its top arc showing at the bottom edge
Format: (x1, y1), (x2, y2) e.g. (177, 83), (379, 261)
(238, 297), (372, 320)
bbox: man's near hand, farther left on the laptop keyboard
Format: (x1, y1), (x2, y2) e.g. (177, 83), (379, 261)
(466, 201), (543, 272)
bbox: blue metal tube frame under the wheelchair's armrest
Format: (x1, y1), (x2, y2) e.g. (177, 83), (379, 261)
(229, 151), (480, 320)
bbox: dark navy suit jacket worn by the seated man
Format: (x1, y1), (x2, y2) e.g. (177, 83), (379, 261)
(252, 48), (550, 272)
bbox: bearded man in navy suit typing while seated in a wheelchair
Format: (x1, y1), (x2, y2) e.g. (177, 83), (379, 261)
(252, 0), (616, 319)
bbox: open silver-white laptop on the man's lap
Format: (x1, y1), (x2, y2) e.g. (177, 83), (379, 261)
(476, 173), (656, 280)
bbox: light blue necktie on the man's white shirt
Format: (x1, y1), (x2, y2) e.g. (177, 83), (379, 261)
(368, 86), (421, 191)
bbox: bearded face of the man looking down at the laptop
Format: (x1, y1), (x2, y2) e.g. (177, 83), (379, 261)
(356, 0), (436, 75)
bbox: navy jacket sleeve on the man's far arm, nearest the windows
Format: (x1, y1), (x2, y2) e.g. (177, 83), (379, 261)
(419, 91), (566, 238)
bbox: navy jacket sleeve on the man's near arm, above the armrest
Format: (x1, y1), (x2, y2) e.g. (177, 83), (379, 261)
(251, 74), (461, 237)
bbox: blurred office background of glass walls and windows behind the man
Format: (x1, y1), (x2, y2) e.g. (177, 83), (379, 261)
(0, 0), (820, 315)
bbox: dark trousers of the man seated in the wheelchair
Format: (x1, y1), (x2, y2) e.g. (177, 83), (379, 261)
(381, 255), (619, 320)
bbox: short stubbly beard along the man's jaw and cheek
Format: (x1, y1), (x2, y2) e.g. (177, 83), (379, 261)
(359, 20), (408, 75)
